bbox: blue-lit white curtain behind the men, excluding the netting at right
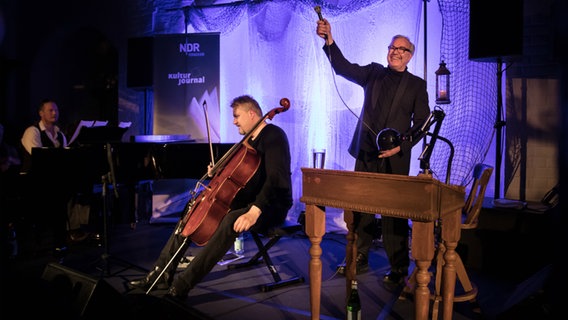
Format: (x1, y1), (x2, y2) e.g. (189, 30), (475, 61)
(156, 0), (422, 224)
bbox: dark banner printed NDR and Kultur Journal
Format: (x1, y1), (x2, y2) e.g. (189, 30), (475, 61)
(153, 33), (220, 142)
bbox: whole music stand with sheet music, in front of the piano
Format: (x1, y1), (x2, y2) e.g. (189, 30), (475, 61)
(77, 126), (148, 276)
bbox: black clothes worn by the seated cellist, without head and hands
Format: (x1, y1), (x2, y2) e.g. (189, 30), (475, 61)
(131, 124), (292, 298)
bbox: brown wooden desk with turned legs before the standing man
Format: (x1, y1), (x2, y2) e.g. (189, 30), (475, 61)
(300, 168), (465, 320)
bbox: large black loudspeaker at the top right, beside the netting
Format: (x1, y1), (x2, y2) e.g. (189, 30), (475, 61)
(469, 0), (523, 62)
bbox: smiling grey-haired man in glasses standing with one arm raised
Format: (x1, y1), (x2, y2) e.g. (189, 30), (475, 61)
(316, 19), (430, 289)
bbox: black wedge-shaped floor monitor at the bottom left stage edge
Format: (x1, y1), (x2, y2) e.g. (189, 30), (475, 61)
(39, 263), (125, 319)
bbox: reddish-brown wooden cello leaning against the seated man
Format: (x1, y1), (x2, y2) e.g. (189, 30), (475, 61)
(175, 98), (290, 246)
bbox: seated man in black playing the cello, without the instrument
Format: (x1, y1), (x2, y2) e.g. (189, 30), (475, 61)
(129, 95), (292, 300)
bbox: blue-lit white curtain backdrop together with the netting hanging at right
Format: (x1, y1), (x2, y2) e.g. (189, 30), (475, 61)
(144, 0), (496, 231)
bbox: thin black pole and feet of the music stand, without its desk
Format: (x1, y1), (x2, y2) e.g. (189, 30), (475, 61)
(96, 142), (148, 276)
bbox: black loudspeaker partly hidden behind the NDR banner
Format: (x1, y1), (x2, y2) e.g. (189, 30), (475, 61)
(126, 37), (154, 88)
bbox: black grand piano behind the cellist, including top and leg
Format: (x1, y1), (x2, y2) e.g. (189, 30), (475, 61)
(29, 136), (233, 224)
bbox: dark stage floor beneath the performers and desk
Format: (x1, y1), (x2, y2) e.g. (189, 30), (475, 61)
(2, 216), (548, 320)
